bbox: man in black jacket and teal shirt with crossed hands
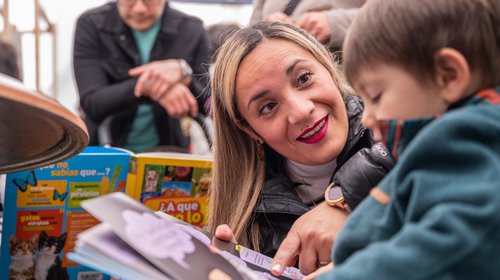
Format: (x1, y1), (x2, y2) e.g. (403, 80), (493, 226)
(74, 0), (210, 152)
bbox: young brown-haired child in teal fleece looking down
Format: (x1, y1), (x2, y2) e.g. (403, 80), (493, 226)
(310, 0), (500, 279)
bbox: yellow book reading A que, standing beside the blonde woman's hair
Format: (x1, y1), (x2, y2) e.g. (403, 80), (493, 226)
(126, 152), (212, 227)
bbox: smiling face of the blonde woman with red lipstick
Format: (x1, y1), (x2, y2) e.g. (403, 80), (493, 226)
(236, 39), (348, 165)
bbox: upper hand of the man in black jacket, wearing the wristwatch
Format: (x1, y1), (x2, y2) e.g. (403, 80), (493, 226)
(129, 59), (182, 98)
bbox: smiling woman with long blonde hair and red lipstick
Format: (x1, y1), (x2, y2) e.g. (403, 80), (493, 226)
(208, 21), (392, 274)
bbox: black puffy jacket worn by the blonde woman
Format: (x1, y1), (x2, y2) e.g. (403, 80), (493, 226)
(254, 96), (394, 257)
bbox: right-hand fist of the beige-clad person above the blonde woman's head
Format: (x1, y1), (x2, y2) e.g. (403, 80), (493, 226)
(295, 12), (332, 43)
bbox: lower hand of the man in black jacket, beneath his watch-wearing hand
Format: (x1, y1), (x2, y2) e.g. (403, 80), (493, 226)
(156, 83), (198, 119)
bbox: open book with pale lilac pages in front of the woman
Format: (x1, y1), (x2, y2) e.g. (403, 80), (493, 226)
(68, 192), (303, 280)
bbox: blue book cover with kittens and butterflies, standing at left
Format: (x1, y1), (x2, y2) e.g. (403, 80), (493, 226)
(0, 147), (130, 280)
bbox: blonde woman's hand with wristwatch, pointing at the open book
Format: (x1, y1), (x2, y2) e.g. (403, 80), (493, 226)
(271, 203), (347, 276)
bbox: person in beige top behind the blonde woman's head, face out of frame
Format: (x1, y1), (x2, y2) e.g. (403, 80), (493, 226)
(250, 0), (366, 52)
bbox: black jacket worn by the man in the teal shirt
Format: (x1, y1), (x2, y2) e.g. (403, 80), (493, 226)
(73, 2), (210, 147)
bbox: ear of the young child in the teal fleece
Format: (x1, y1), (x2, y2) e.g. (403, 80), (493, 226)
(434, 48), (471, 104)
